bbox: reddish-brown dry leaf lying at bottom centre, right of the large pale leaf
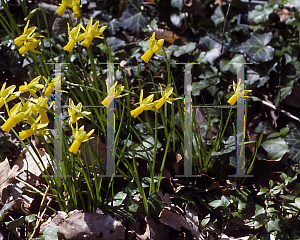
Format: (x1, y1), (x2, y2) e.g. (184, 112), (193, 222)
(159, 208), (192, 231)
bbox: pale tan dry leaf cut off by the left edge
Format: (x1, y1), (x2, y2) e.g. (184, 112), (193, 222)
(0, 158), (24, 203)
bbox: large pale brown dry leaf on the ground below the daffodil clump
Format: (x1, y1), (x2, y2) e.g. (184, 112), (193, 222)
(40, 210), (125, 240)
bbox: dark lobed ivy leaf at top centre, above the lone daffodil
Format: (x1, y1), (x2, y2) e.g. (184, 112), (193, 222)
(120, 0), (150, 35)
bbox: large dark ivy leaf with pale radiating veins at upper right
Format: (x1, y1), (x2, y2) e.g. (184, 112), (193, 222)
(236, 32), (275, 62)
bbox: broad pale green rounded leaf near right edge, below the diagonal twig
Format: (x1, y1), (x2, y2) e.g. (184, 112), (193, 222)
(261, 138), (289, 160)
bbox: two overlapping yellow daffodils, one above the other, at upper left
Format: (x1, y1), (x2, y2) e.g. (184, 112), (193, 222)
(14, 20), (43, 55)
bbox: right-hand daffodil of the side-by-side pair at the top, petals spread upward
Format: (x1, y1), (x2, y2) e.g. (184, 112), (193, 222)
(78, 18), (107, 47)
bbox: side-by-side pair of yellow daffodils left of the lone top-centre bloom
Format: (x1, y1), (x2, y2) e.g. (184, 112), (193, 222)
(64, 18), (107, 52)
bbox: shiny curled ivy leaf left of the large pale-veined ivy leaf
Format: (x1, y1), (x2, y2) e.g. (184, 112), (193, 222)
(199, 36), (224, 65)
